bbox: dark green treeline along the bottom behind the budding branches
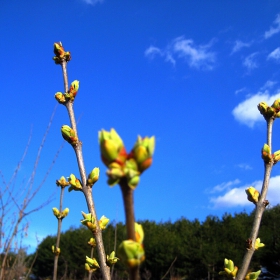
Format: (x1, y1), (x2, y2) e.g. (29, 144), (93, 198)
(33, 206), (280, 280)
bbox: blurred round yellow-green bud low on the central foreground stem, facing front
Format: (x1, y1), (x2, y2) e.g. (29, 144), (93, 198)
(118, 240), (145, 268)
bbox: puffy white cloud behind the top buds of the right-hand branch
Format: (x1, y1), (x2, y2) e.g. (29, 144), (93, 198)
(232, 91), (280, 127)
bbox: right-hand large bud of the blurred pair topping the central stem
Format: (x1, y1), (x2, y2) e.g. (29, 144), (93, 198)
(131, 136), (155, 172)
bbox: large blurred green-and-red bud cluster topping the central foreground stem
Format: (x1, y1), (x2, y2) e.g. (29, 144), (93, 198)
(98, 129), (155, 189)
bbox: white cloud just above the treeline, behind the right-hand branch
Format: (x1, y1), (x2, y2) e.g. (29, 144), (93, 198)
(210, 176), (280, 208)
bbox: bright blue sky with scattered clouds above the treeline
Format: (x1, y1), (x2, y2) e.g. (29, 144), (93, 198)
(0, 0), (280, 253)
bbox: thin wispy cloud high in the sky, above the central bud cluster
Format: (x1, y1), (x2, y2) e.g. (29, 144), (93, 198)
(145, 36), (216, 70)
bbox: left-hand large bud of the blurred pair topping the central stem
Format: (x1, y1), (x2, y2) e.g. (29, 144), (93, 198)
(98, 128), (126, 166)
